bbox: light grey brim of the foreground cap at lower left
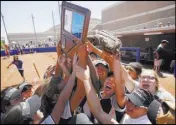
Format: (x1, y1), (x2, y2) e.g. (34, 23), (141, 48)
(26, 95), (41, 117)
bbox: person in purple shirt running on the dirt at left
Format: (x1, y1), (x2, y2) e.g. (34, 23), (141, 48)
(7, 55), (25, 81)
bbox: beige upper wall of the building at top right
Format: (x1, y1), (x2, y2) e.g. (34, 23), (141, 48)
(102, 1), (175, 23)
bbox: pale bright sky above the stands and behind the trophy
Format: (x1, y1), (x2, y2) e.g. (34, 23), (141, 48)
(1, 1), (117, 43)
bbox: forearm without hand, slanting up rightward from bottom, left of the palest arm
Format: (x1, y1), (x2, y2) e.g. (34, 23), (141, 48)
(51, 72), (75, 124)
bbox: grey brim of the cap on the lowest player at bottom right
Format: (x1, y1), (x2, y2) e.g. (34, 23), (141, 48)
(126, 93), (144, 107)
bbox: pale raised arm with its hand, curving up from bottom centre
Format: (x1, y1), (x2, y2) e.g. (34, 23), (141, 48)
(76, 66), (117, 124)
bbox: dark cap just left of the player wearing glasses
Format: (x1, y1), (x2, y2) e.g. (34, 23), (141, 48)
(127, 62), (142, 75)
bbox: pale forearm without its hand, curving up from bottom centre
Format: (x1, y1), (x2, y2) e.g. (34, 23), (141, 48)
(83, 79), (117, 124)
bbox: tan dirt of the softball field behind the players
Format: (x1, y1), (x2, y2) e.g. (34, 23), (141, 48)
(1, 52), (175, 96)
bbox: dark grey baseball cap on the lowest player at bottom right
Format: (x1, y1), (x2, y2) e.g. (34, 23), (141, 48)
(126, 89), (154, 107)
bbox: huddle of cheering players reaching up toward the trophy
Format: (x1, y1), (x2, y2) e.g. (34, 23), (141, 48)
(1, 30), (175, 124)
